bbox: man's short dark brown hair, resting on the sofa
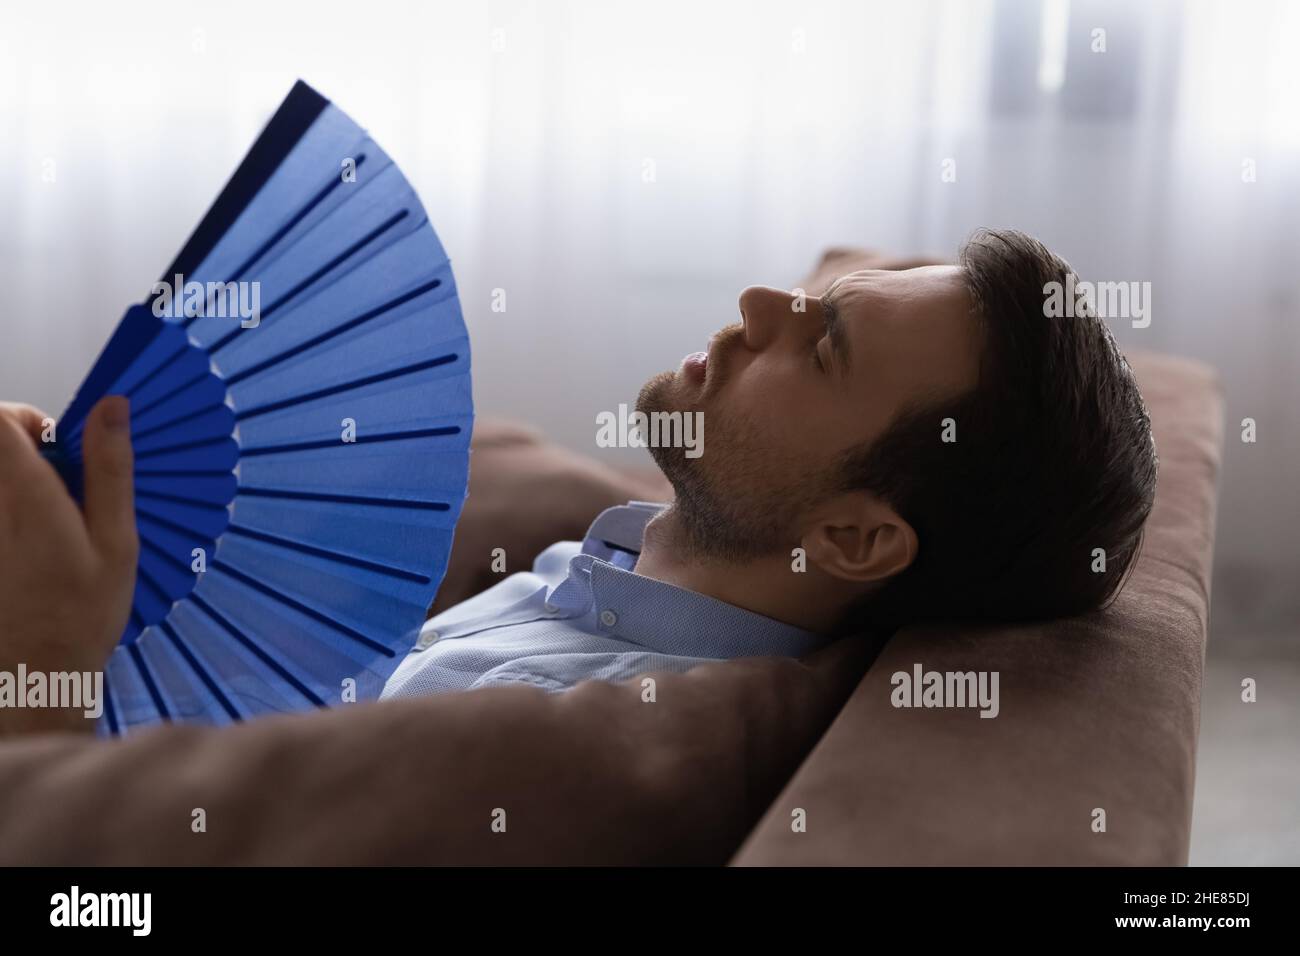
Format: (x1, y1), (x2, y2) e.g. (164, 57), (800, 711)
(842, 229), (1157, 630)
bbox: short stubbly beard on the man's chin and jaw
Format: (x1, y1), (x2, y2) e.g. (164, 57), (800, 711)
(636, 368), (822, 563)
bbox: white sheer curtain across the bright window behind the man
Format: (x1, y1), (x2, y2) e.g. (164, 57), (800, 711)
(0, 0), (1300, 624)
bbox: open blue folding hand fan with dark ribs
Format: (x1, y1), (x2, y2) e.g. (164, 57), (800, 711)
(47, 82), (473, 734)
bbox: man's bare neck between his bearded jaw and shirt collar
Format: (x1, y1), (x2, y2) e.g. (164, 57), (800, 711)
(633, 506), (846, 633)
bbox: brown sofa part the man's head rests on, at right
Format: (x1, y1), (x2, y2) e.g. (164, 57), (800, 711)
(733, 355), (1222, 866)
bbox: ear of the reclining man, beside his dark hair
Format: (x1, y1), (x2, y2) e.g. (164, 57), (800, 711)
(800, 492), (919, 583)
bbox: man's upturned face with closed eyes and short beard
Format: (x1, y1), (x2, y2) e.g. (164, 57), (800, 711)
(637, 265), (980, 561)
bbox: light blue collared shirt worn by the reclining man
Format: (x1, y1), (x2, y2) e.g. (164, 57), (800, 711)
(380, 501), (823, 700)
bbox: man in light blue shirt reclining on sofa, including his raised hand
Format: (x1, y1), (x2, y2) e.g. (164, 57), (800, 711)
(0, 232), (1156, 731)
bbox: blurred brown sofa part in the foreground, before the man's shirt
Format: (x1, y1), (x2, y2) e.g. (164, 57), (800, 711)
(0, 639), (872, 866)
